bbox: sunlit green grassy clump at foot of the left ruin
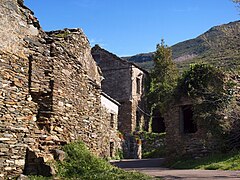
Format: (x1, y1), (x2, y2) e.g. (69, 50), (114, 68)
(31, 142), (152, 180)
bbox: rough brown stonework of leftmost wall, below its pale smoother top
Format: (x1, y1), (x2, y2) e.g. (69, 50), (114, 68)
(0, 51), (40, 178)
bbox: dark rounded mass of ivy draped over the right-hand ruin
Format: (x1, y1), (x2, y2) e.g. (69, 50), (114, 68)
(175, 64), (232, 136)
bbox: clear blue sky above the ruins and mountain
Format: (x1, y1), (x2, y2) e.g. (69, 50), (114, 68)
(25, 0), (240, 56)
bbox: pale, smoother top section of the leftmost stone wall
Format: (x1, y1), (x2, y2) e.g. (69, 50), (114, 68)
(0, 0), (39, 57)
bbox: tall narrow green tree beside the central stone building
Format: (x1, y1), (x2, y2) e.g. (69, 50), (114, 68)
(149, 40), (178, 114)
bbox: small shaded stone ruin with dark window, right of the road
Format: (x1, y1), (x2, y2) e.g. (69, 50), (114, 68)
(164, 98), (211, 158)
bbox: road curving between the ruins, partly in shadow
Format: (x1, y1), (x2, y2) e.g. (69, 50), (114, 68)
(111, 158), (240, 180)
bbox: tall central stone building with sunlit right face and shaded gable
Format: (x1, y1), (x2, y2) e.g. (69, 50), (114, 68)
(92, 45), (148, 133)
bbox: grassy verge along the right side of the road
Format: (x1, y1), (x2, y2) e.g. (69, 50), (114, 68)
(170, 152), (240, 170)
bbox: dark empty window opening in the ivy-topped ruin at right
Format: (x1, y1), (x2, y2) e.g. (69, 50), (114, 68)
(181, 105), (197, 134)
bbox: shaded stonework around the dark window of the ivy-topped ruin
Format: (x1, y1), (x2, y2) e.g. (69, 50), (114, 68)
(164, 98), (215, 159)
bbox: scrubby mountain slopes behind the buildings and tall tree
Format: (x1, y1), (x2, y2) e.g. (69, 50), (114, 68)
(123, 21), (240, 70)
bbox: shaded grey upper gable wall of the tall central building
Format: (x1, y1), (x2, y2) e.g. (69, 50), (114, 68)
(92, 46), (132, 102)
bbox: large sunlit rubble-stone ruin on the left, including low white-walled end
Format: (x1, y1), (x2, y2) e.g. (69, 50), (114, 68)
(0, 0), (118, 178)
